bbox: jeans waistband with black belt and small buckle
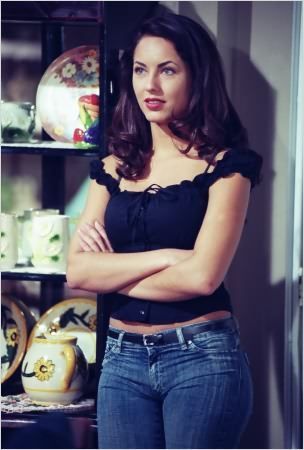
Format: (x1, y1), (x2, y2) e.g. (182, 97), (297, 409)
(108, 317), (238, 346)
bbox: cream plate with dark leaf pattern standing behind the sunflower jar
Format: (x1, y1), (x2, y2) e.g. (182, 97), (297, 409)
(28, 298), (96, 364)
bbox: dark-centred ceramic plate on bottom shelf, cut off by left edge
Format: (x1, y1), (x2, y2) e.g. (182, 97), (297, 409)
(1, 295), (28, 383)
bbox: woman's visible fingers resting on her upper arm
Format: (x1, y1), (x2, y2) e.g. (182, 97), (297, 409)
(77, 220), (114, 253)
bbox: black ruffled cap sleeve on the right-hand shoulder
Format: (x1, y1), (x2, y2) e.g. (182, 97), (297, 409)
(208, 148), (263, 190)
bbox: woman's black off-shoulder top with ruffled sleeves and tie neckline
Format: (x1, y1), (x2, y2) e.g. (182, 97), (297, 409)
(90, 148), (263, 324)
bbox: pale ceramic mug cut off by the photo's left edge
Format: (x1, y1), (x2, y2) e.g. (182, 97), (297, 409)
(0, 213), (18, 270)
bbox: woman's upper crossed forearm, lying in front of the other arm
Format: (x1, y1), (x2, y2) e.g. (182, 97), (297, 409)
(67, 249), (176, 293)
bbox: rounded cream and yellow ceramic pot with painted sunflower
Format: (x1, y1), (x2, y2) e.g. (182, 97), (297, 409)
(21, 334), (88, 405)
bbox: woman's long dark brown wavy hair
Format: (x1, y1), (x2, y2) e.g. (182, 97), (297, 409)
(108, 13), (248, 179)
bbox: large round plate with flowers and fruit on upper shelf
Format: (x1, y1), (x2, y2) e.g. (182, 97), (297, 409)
(36, 45), (99, 143)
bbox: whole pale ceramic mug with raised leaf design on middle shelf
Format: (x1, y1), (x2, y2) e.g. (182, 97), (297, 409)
(31, 214), (69, 272)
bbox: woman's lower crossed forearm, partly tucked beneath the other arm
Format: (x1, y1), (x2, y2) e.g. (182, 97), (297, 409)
(119, 256), (213, 302)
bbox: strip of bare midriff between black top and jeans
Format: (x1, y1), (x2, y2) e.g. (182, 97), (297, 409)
(110, 311), (231, 334)
